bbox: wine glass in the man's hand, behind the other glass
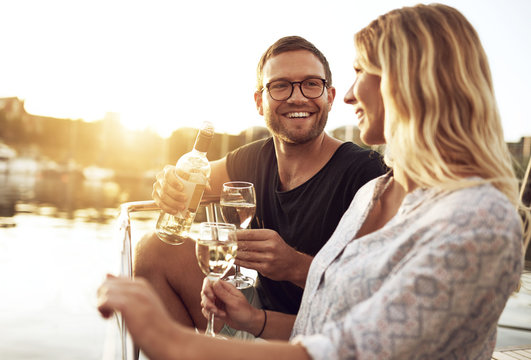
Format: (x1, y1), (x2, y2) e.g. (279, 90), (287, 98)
(219, 181), (256, 290)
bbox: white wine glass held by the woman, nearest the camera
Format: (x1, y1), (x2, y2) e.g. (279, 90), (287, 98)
(195, 222), (238, 337)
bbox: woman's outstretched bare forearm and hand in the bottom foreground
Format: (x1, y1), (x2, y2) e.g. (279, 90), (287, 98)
(98, 276), (309, 360)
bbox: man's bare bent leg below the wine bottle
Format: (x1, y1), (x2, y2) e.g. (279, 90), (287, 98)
(133, 234), (206, 330)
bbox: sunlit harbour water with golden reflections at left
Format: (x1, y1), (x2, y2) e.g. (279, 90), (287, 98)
(0, 158), (195, 360)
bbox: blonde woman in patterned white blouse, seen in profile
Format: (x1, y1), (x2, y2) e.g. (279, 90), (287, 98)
(99, 4), (530, 359)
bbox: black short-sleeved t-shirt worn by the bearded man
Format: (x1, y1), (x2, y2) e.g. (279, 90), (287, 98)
(227, 138), (385, 314)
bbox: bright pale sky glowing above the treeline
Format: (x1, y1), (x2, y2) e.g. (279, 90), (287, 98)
(0, 0), (531, 141)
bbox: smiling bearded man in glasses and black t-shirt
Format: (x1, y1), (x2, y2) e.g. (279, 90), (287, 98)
(134, 36), (384, 335)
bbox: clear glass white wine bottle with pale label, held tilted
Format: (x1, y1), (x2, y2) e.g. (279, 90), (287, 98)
(156, 122), (214, 245)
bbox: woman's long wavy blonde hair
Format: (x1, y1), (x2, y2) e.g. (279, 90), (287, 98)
(355, 4), (531, 253)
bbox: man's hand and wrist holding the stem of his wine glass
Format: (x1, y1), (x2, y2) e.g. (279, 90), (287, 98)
(236, 229), (313, 288)
